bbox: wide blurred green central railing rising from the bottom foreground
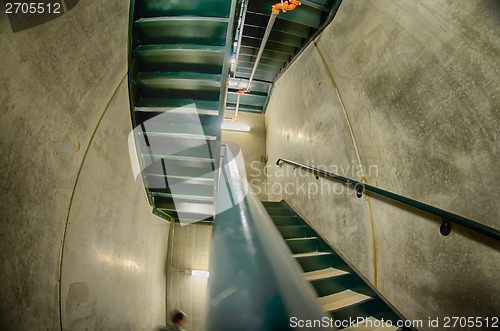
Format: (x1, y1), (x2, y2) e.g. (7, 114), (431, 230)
(207, 145), (326, 330)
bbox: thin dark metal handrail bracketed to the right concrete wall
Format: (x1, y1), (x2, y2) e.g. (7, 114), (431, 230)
(276, 158), (500, 241)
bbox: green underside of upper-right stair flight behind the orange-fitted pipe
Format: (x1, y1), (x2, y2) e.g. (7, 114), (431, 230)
(227, 0), (340, 112)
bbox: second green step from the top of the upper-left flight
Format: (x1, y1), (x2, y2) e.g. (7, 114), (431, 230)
(135, 17), (228, 46)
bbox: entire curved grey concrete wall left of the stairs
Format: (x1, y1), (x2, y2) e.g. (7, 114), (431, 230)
(0, 0), (168, 330)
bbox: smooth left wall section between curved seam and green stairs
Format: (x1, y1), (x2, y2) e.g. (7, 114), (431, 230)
(61, 79), (170, 330)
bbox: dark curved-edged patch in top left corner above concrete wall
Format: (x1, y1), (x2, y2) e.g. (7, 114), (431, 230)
(4, 0), (80, 33)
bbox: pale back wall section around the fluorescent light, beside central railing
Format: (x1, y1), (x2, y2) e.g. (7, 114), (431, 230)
(222, 111), (267, 200)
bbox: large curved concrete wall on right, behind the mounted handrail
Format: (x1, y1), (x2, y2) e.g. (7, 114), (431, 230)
(266, 0), (500, 329)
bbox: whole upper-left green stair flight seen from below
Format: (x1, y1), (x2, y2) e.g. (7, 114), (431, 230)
(128, 0), (236, 221)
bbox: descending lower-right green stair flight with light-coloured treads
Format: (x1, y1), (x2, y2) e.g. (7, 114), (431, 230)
(263, 201), (405, 330)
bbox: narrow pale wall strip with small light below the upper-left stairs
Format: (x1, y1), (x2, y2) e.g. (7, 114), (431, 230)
(166, 224), (212, 330)
